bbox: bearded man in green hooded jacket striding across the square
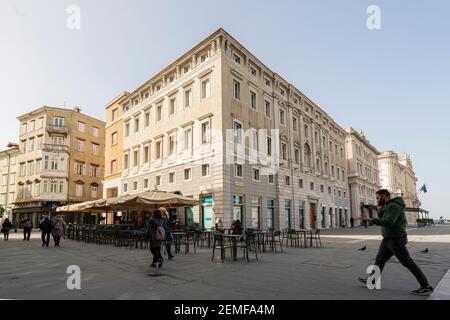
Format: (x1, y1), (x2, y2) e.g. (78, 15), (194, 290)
(359, 189), (433, 295)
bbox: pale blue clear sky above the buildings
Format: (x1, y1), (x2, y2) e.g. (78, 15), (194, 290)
(0, 0), (450, 218)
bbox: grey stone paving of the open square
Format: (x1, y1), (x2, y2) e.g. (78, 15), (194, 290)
(0, 225), (450, 300)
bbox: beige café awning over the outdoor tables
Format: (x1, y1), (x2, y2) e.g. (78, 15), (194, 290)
(56, 191), (200, 213)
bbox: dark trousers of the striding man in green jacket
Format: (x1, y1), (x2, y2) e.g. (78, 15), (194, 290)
(375, 237), (428, 287)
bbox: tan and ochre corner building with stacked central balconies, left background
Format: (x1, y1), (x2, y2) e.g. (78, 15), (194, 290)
(13, 107), (105, 225)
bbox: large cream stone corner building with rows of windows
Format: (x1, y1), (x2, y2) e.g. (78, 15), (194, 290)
(113, 29), (350, 229)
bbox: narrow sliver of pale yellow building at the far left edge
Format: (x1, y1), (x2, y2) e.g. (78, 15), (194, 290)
(0, 144), (19, 216)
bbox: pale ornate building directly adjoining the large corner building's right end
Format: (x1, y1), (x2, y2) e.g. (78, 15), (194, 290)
(345, 128), (380, 218)
